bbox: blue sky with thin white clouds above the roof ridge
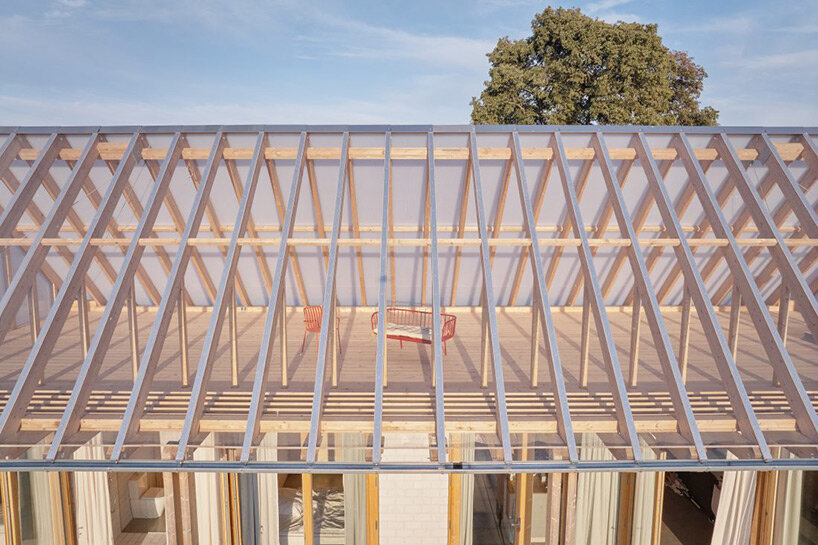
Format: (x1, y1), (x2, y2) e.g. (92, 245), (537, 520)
(0, 0), (818, 125)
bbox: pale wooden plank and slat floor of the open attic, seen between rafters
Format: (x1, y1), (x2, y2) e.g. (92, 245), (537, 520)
(0, 308), (818, 456)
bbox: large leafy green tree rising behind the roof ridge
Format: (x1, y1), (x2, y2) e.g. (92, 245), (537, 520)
(471, 8), (719, 125)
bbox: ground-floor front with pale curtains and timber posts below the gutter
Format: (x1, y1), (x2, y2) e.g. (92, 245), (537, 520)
(0, 433), (818, 545)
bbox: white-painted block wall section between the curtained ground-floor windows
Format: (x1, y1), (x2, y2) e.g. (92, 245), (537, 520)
(379, 434), (449, 545)
